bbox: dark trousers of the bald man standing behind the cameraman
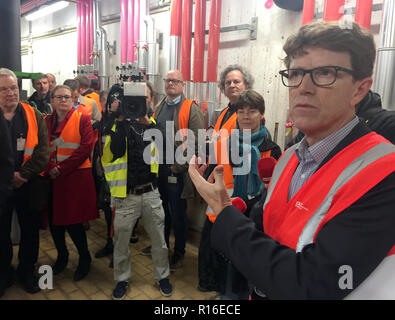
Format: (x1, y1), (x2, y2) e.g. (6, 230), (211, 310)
(158, 170), (188, 255)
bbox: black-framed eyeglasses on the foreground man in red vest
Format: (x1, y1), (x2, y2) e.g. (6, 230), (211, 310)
(279, 66), (354, 88)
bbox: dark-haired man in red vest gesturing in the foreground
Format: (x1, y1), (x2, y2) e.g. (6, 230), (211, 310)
(189, 22), (395, 299)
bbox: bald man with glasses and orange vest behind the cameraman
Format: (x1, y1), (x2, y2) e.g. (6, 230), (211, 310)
(154, 70), (204, 271)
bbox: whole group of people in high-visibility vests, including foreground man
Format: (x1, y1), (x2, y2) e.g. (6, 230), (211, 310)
(0, 22), (395, 300)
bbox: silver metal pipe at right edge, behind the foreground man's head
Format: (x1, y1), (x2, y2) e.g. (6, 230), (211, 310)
(373, 1), (395, 110)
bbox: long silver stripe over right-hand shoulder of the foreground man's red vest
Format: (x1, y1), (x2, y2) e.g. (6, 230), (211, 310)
(296, 143), (395, 252)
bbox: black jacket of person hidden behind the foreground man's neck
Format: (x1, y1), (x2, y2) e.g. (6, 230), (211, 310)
(286, 91), (395, 149)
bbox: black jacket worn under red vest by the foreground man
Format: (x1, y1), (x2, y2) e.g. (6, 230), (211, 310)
(211, 122), (395, 299)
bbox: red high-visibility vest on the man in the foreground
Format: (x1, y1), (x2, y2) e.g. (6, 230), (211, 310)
(263, 132), (395, 299)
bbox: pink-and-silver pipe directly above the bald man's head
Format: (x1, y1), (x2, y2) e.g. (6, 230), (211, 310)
(169, 0), (182, 70)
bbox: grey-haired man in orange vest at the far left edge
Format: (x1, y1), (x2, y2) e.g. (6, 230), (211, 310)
(0, 68), (49, 296)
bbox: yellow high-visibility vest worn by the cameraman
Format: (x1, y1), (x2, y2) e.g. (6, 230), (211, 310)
(101, 117), (159, 198)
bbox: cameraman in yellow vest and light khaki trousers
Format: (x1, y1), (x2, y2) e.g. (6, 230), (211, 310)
(102, 82), (173, 300)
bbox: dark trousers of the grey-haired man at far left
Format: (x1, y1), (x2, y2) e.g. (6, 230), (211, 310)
(0, 182), (41, 277)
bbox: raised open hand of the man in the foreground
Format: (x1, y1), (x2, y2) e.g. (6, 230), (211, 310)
(188, 156), (232, 215)
